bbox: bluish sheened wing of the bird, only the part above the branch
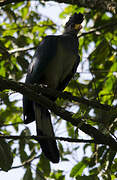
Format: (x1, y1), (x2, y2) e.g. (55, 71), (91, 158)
(26, 36), (57, 84)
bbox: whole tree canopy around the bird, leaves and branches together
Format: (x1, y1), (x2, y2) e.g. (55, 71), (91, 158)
(0, 0), (117, 180)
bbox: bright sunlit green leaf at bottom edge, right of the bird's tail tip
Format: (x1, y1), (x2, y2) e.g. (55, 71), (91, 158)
(70, 161), (86, 177)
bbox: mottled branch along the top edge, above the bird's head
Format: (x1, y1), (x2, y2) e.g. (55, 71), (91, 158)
(0, 0), (117, 13)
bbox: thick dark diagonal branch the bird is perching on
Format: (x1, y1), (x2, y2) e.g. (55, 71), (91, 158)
(0, 76), (117, 150)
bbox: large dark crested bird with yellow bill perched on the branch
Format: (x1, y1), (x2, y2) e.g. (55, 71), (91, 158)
(23, 13), (84, 163)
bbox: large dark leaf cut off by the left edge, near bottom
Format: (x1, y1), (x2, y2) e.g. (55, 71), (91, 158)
(0, 139), (13, 171)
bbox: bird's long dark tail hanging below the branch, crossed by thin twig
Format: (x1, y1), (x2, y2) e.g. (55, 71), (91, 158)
(34, 103), (59, 163)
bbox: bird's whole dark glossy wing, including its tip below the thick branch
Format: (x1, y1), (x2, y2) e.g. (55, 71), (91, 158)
(23, 36), (57, 124)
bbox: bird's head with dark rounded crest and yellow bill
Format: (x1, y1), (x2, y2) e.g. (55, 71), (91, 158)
(65, 13), (84, 34)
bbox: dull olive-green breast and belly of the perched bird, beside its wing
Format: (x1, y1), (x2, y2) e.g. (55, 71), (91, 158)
(43, 37), (77, 88)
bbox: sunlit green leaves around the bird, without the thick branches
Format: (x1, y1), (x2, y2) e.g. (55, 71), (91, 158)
(0, 1), (117, 180)
